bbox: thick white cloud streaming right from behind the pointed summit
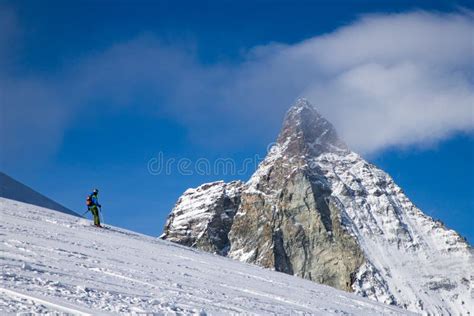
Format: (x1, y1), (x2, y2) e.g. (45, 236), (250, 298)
(218, 12), (474, 153)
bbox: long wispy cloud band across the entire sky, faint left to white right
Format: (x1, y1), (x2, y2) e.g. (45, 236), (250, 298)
(0, 11), (474, 164)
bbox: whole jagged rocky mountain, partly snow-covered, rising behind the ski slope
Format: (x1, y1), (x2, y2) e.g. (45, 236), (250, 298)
(162, 99), (474, 314)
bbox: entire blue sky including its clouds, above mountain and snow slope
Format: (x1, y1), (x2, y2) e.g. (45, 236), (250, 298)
(0, 1), (474, 242)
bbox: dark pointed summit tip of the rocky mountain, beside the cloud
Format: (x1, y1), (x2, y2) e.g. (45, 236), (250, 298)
(277, 98), (348, 156)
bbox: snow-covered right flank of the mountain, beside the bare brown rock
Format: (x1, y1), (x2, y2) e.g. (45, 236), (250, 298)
(312, 153), (474, 315)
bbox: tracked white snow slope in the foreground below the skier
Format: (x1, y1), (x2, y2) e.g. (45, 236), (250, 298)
(0, 198), (409, 315)
